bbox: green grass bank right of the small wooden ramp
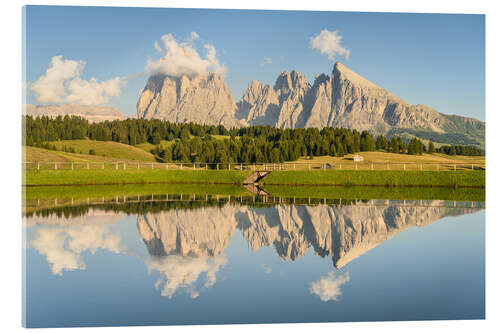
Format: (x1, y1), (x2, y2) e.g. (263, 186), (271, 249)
(263, 170), (485, 188)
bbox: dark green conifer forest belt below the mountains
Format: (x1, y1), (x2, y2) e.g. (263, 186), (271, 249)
(23, 116), (484, 164)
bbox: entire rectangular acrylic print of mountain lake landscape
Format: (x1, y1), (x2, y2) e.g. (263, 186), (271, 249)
(22, 6), (486, 327)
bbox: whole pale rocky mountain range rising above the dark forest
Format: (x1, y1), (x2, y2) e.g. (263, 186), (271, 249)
(137, 62), (485, 147)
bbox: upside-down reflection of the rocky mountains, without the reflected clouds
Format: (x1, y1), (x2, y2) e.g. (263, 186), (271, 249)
(137, 201), (478, 268)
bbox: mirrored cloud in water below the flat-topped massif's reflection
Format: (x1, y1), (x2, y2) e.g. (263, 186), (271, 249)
(146, 255), (227, 298)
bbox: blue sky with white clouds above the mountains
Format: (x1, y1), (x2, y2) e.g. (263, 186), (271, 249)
(24, 6), (485, 121)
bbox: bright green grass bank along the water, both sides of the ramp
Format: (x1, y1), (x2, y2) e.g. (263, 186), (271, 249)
(24, 169), (485, 188)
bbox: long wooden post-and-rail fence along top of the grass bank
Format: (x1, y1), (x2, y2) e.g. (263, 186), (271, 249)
(23, 161), (486, 171)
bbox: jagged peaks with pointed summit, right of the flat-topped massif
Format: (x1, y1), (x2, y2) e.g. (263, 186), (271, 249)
(237, 62), (485, 145)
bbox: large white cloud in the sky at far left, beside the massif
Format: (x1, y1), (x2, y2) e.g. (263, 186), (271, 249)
(30, 55), (127, 105)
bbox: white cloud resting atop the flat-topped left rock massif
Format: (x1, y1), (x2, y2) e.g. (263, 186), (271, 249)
(146, 32), (227, 77)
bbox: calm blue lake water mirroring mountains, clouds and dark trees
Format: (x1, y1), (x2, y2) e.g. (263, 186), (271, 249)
(23, 196), (485, 327)
